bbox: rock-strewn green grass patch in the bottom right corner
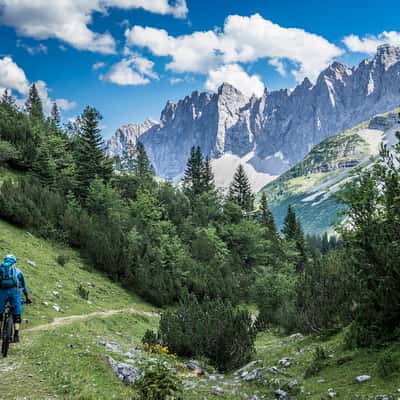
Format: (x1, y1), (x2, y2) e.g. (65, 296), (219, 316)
(257, 332), (400, 400)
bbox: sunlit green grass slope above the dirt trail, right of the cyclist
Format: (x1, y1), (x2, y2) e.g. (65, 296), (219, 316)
(0, 220), (155, 326)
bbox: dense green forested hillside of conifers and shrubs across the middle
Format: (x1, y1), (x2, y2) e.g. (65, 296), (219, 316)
(0, 85), (400, 398)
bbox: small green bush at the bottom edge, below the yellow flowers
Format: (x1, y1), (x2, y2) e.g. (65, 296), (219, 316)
(136, 361), (183, 400)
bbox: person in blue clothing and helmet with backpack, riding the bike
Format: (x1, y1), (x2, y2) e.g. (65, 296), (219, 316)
(0, 254), (31, 343)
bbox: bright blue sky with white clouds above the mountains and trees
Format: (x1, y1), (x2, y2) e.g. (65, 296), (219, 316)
(0, 0), (400, 136)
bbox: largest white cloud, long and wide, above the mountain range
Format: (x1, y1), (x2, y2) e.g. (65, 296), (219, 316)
(125, 14), (343, 81)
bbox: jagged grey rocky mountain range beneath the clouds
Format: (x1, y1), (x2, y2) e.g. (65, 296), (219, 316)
(108, 45), (400, 191)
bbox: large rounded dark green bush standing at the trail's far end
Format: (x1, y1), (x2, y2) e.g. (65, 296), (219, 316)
(159, 295), (256, 371)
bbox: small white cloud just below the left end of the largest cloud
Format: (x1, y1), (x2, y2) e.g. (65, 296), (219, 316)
(100, 56), (158, 86)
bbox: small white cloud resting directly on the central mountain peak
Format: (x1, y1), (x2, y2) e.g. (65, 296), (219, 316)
(206, 64), (264, 97)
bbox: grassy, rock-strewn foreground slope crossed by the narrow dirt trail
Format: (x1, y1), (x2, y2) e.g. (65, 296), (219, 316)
(0, 185), (400, 400)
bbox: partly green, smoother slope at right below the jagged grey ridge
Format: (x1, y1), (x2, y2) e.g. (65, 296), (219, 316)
(263, 109), (400, 234)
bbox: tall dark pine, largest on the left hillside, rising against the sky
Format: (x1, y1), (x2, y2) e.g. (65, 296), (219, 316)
(75, 107), (110, 199)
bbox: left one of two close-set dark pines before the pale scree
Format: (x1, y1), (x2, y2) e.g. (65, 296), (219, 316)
(183, 146), (205, 198)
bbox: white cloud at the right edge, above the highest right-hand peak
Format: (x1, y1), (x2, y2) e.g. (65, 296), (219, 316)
(343, 31), (400, 54)
